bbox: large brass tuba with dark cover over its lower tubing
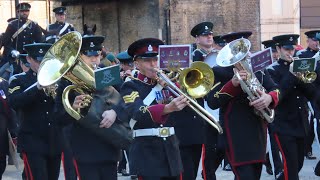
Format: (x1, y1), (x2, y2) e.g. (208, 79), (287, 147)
(37, 31), (132, 149)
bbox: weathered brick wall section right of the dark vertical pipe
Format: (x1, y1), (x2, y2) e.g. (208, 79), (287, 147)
(170, 0), (260, 50)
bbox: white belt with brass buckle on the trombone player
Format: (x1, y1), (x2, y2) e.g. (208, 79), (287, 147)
(133, 127), (175, 138)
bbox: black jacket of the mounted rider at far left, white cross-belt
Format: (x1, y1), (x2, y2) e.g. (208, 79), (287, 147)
(3, 19), (42, 57)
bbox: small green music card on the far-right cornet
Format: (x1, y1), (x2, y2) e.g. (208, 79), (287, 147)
(290, 58), (317, 72)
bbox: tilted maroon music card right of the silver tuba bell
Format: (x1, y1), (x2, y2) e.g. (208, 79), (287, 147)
(250, 47), (273, 73)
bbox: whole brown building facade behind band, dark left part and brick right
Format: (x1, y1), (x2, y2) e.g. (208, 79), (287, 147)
(62, 0), (261, 52)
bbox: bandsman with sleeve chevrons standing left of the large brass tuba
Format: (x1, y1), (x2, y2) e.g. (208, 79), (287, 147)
(8, 43), (62, 180)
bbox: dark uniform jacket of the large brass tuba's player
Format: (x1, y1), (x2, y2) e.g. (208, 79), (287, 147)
(54, 78), (120, 163)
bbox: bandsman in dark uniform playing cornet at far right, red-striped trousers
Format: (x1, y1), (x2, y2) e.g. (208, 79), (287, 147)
(268, 34), (319, 180)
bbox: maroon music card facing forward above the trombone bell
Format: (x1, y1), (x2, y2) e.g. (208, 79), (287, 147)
(158, 44), (192, 71)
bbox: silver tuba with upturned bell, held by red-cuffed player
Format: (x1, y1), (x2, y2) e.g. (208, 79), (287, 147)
(217, 38), (274, 123)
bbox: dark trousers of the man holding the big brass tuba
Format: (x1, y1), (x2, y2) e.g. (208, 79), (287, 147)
(77, 162), (117, 180)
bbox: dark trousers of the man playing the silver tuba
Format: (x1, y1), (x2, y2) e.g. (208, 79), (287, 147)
(232, 163), (262, 180)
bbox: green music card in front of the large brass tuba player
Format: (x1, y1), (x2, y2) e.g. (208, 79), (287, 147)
(94, 64), (121, 90)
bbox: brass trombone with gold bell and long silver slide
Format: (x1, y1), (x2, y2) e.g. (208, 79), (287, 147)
(155, 62), (223, 134)
